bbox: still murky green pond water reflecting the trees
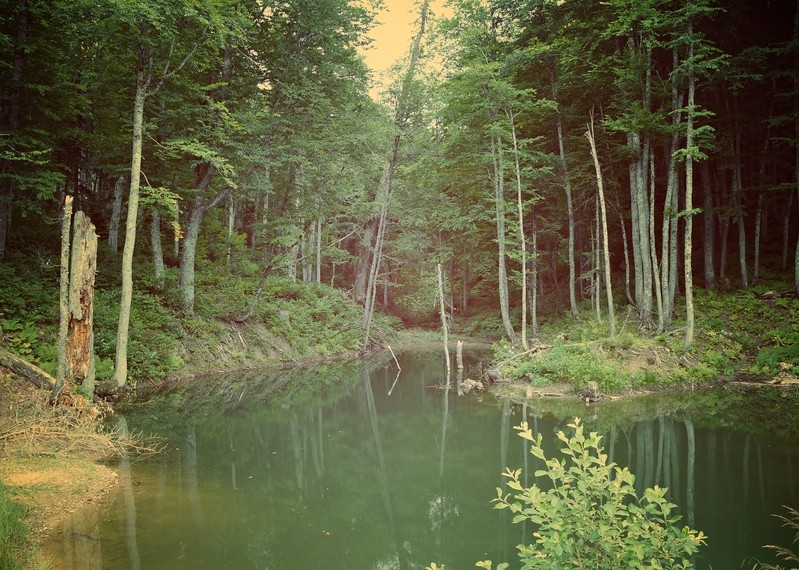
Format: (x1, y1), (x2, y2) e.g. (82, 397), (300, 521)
(47, 353), (799, 570)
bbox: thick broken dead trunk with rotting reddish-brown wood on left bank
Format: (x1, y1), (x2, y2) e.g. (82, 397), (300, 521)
(66, 212), (97, 392)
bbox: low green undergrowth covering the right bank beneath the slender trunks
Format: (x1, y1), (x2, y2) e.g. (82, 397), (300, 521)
(482, 283), (799, 393)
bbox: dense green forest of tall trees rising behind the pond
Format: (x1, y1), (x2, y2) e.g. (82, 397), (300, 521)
(0, 0), (799, 386)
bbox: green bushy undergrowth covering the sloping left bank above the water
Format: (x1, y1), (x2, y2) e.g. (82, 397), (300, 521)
(0, 248), (388, 382)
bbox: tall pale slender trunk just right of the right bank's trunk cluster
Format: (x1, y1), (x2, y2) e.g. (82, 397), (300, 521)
(683, 13), (695, 350)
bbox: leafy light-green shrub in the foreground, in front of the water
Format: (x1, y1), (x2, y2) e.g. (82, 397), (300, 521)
(483, 419), (706, 569)
